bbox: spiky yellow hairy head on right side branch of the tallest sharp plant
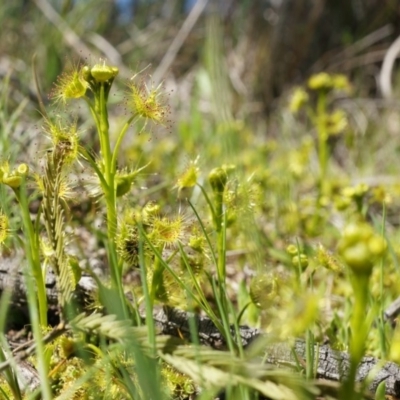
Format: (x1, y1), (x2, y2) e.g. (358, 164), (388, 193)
(126, 75), (169, 124)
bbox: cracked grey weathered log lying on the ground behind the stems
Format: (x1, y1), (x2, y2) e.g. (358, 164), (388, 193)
(0, 255), (400, 397)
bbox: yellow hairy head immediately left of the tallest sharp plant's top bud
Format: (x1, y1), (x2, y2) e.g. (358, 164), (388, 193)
(50, 61), (89, 105)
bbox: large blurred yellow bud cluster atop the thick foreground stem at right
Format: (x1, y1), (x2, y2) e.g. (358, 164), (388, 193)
(338, 222), (386, 275)
